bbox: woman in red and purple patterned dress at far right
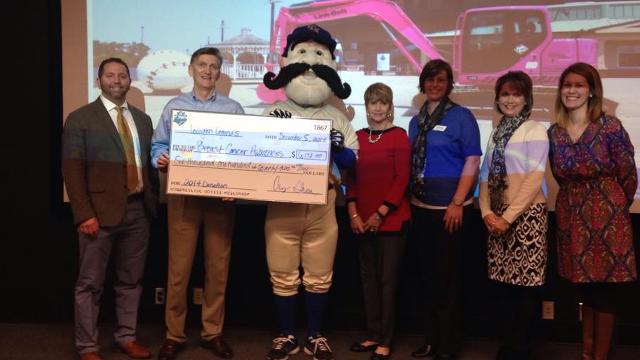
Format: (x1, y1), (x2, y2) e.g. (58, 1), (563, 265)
(549, 63), (638, 360)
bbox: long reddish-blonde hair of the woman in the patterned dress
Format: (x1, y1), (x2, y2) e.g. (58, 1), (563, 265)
(555, 62), (603, 128)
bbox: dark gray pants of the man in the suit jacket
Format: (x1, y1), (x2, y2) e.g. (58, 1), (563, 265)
(74, 196), (149, 353)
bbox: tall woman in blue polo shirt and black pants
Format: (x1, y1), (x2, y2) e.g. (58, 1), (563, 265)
(409, 59), (482, 359)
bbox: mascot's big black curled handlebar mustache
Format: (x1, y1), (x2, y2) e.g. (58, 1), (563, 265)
(262, 63), (351, 99)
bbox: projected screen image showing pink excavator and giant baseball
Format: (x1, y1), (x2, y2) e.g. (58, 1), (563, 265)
(63, 0), (640, 212)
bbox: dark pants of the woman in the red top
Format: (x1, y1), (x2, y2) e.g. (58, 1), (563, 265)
(358, 232), (404, 346)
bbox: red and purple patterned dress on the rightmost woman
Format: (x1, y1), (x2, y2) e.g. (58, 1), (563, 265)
(549, 115), (638, 283)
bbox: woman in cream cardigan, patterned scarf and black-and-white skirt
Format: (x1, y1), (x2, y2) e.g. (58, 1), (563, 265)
(479, 71), (549, 360)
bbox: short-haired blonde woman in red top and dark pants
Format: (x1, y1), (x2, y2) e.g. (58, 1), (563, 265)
(347, 83), (411, 360)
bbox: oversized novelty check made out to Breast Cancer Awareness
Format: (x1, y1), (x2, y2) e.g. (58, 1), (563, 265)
(167, 110), (331, 204)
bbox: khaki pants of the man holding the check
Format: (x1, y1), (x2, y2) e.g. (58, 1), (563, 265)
(165, 195), (235, 342)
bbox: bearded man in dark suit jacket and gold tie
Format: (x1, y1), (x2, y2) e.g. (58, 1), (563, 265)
(62, 58), (158, 360)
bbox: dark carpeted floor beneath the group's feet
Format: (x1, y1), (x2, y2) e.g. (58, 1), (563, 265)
(0, 323), (640, 360)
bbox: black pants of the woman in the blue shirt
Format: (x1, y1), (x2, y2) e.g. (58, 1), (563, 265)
(411, 206), (472, 354)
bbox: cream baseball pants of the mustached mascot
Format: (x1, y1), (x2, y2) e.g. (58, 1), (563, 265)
(265, 188), (338, 296)
